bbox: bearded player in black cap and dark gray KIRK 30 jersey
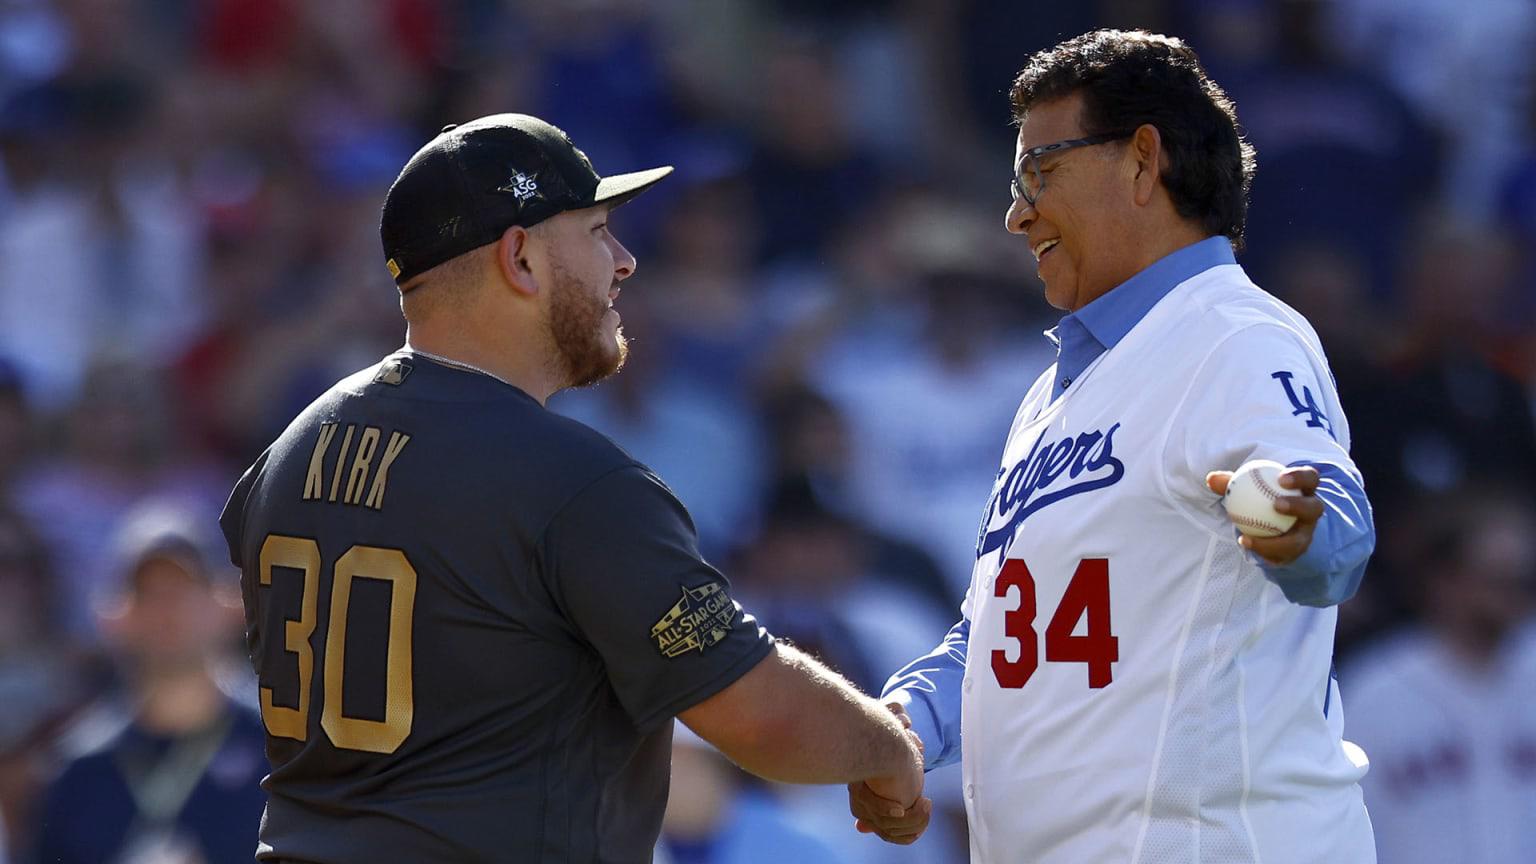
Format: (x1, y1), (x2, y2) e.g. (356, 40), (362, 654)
(221, 114), (929, 864)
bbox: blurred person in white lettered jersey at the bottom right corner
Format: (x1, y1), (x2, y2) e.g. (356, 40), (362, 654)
(1341, 481), (1536, 864)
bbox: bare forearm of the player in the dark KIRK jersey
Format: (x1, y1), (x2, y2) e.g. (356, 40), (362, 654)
(682, 643), (919, 783)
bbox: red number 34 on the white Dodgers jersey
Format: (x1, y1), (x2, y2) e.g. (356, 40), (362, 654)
(992, 558), (1120, 690)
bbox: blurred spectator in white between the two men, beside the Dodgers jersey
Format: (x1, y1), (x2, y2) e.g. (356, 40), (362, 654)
(808, 204), (1052, 596)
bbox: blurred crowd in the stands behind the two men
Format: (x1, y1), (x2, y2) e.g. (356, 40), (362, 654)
(0, 0), (1536, 864)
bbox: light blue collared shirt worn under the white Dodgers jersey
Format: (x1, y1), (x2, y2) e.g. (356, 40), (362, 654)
(883, 237), (1376, 769)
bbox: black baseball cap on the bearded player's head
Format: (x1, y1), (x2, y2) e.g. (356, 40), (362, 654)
(379, 114), (673, 284)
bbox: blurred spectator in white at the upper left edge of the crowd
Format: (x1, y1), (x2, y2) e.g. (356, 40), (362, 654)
(0, 27), (201, 409)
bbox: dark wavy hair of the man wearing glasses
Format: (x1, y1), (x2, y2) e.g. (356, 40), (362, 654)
(1009, 29), (1253, 249)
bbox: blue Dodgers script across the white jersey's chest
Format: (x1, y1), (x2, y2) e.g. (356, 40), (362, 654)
(975, 423), (1126, 558)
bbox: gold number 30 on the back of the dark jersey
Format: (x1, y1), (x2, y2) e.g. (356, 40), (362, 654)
(261, 533), (416, 753)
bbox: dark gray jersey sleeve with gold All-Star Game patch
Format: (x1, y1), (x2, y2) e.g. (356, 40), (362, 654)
(541, 466), (773, 729)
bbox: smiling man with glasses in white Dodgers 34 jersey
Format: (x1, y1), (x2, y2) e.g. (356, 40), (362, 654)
(849, 31), (1375, 864)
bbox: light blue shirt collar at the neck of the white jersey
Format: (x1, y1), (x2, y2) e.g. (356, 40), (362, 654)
(1046, 235), (1236, 400)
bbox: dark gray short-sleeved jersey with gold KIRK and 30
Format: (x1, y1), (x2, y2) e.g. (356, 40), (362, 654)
(221, 352), (771, 864)
